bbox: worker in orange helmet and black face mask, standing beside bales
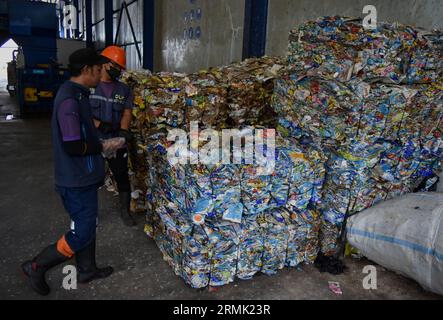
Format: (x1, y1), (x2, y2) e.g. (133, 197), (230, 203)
(90, 46), (136, 226)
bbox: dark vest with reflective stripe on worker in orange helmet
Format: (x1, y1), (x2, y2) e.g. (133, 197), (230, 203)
(90, 82), (131, 139)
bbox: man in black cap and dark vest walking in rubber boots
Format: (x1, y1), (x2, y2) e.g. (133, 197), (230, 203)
(22, 49), (120, 295)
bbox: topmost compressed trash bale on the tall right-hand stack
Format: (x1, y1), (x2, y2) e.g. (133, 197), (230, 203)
(288, 16), (443, 84)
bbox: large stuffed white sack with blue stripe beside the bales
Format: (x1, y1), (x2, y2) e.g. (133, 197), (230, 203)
(347, 193), (443, 295)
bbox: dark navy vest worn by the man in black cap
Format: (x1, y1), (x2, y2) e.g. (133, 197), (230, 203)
(51, 81), (105, 188)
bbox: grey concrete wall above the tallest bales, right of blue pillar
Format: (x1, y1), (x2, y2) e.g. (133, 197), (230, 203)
(266, 0), (443, 55)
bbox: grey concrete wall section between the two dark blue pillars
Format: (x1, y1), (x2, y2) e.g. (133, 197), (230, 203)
(154, 0), (245, 72)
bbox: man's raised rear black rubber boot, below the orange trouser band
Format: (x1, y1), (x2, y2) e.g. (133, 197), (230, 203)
(22, 244), (69, 296)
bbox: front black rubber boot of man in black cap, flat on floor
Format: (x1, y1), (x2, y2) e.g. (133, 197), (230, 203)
(75, 238), (114, 283)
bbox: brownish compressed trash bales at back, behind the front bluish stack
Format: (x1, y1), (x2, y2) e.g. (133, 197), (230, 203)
(122, 57), (285, 216)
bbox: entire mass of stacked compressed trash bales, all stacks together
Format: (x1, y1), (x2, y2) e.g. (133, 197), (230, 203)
(120, 17), (443, 288)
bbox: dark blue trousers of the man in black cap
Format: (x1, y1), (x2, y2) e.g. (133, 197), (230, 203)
(55, 185), (99, 252)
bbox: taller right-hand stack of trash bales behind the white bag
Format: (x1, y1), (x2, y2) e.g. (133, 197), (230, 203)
(273, 17), (443, 254)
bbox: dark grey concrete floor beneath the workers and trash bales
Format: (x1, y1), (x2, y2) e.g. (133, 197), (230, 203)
(0, 94), (442, 300)
